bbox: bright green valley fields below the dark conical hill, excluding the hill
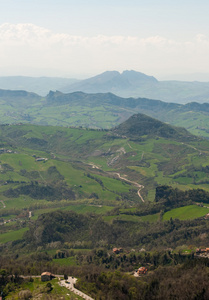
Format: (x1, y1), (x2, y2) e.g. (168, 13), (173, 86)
(0, 121), (209, 242)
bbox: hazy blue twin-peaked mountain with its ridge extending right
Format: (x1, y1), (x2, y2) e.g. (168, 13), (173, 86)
(60, 71), (209, 103)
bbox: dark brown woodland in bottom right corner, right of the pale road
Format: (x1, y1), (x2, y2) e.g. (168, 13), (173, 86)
(76, 259), (209, 300)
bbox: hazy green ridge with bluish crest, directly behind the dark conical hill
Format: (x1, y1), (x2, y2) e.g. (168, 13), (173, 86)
(0, 90), (209, 138)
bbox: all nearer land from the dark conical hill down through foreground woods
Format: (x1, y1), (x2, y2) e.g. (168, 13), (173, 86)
(0, 118), (209, 300)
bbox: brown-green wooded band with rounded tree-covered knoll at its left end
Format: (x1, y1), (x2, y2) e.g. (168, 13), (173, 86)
(22, 211), (209, 249)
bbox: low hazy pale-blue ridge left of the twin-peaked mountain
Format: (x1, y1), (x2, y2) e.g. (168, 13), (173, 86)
(0, 76), (78, 96)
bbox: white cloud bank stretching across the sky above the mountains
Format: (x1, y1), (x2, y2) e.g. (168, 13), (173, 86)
(0, 23), (209, 76)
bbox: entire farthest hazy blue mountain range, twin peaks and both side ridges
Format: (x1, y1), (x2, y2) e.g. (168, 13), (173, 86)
(0, 71), (209, 103)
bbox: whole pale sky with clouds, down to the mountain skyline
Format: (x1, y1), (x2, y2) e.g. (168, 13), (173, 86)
(0, 0), (209, 81)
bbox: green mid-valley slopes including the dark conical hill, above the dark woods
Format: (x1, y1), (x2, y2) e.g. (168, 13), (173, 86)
(0, 114), (204, 204)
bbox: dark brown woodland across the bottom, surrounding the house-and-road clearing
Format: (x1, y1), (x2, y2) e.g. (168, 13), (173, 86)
(0, 253), (209, 300)
